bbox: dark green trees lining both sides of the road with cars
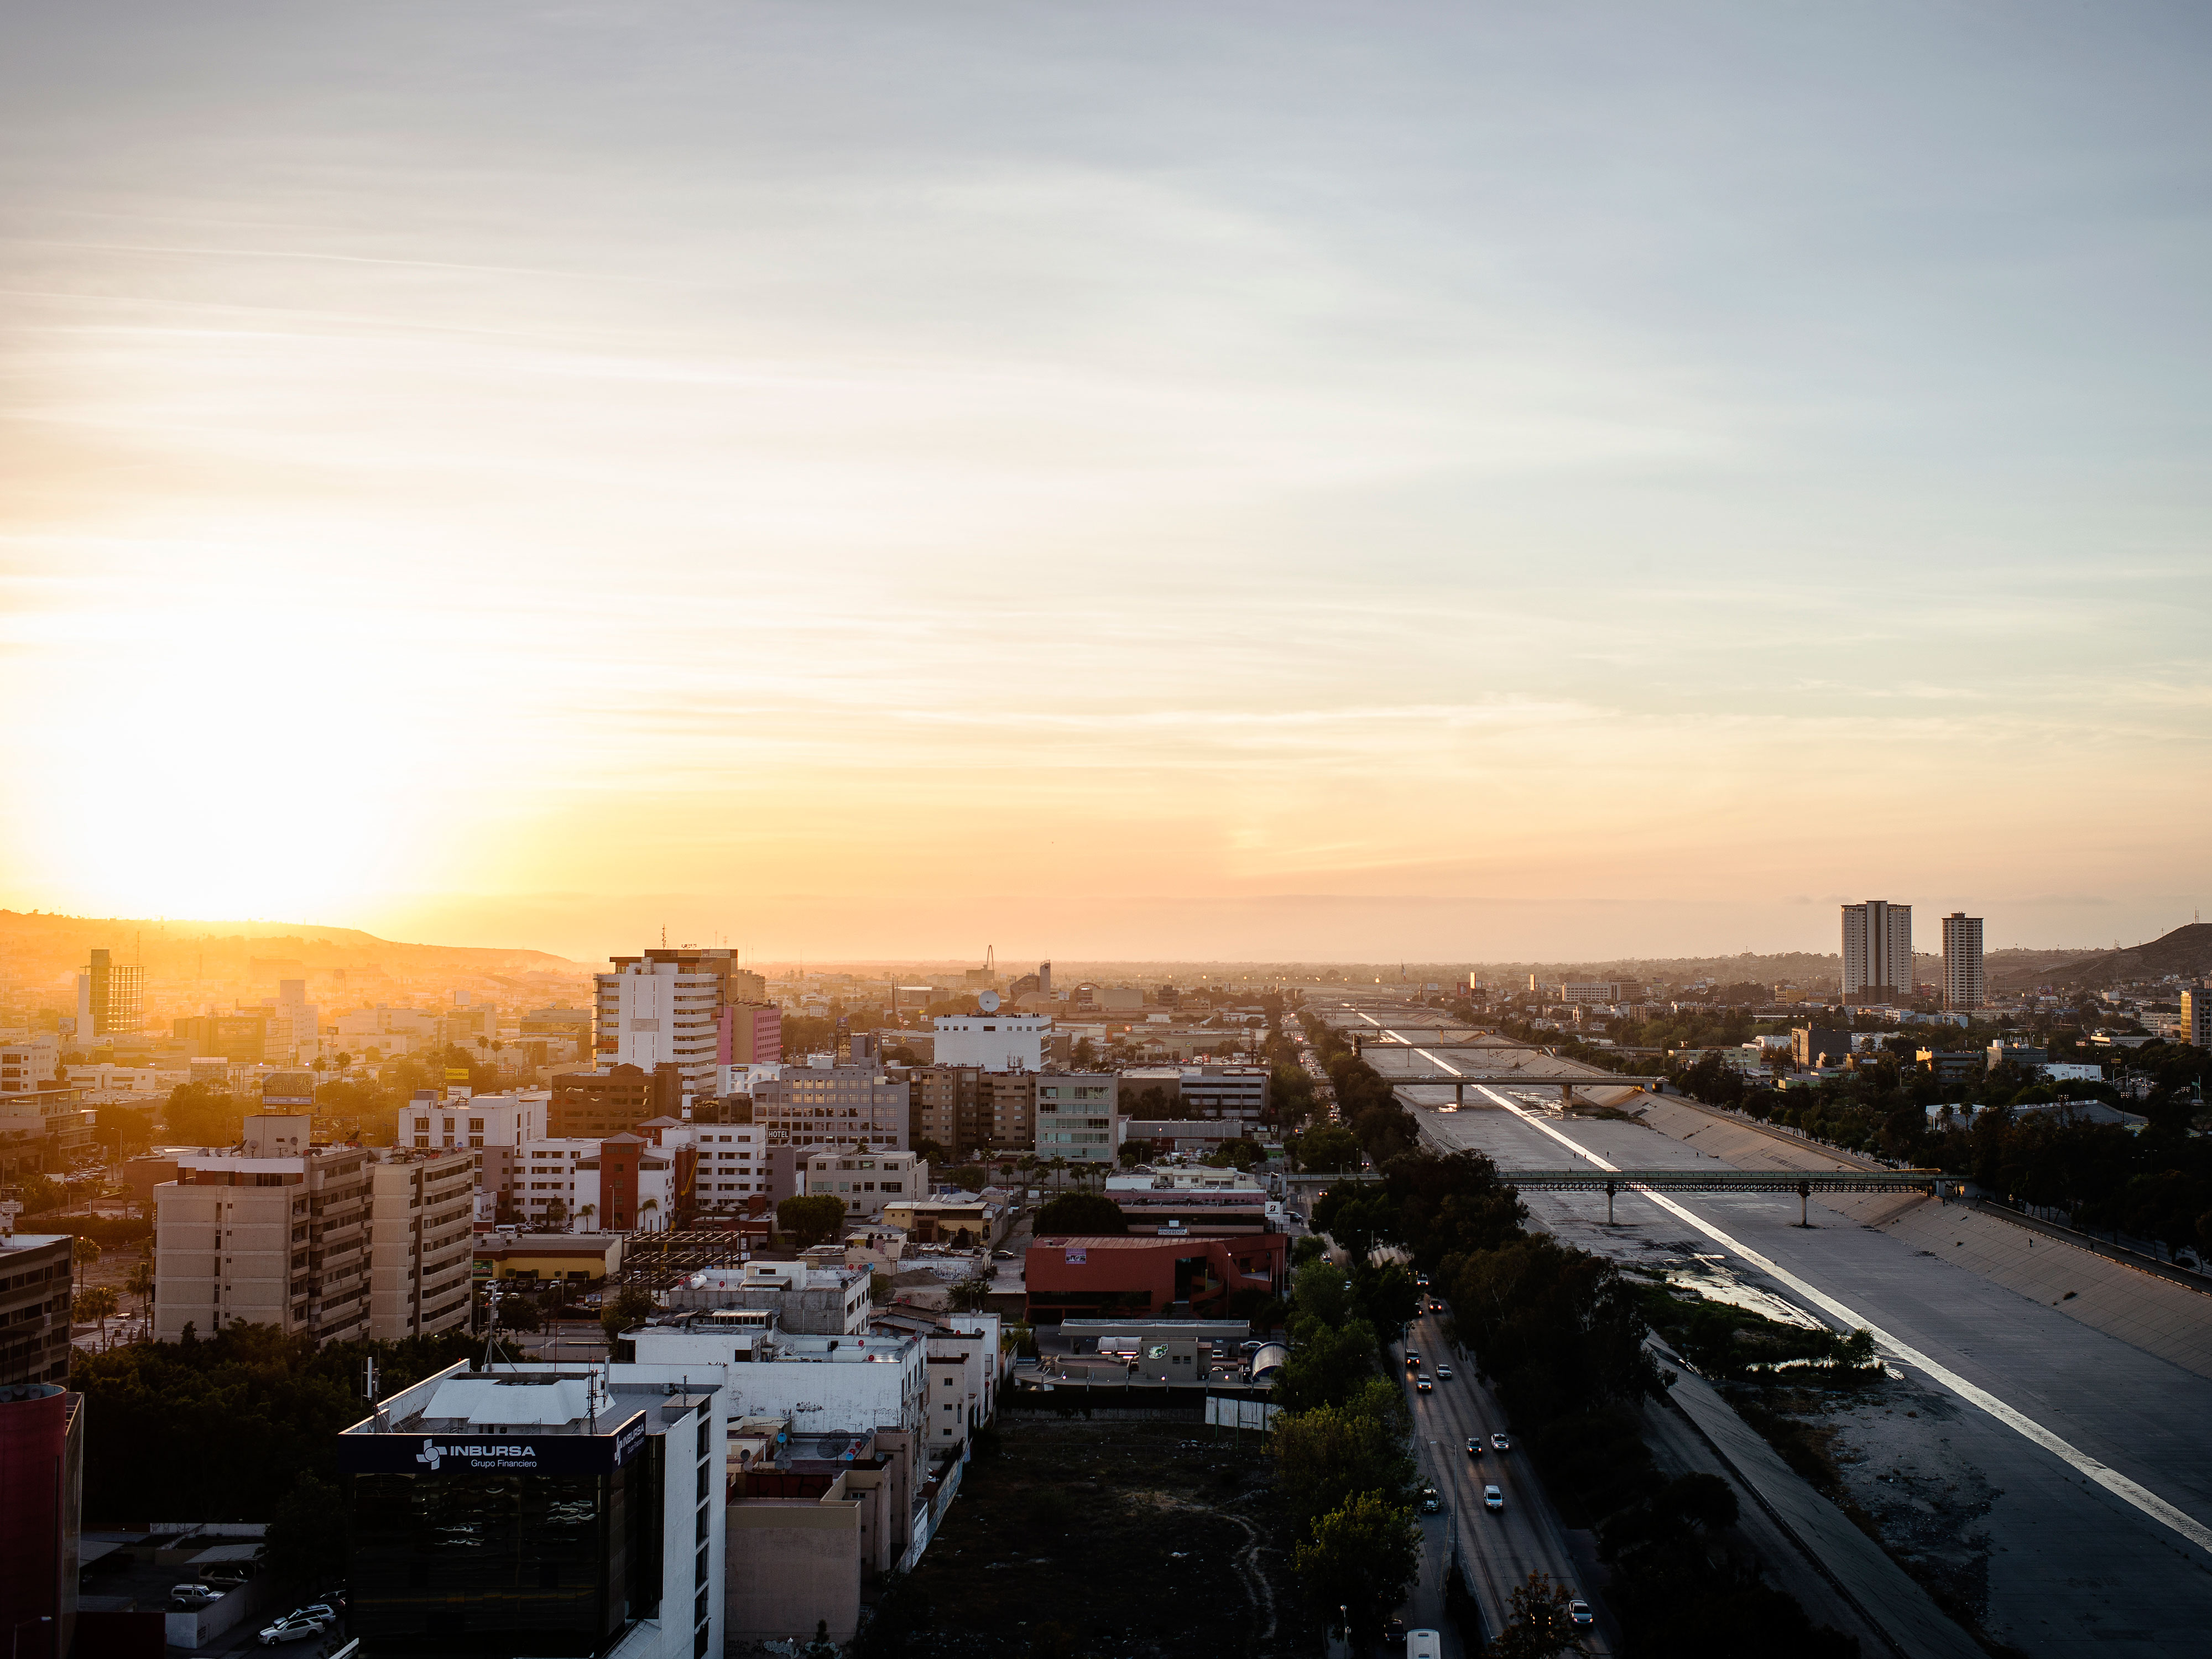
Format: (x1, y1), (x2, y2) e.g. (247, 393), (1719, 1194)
(1276, 1150), (1858, 1659)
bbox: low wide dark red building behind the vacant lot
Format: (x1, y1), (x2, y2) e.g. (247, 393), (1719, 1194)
(1024, 1232), (1290, 1325)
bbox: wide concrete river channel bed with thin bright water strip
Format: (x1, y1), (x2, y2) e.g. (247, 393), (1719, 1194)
(1318, 1004), (2212, 1659)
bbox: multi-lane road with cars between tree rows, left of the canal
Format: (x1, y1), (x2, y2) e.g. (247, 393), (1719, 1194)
(1394, 1316), (1617, 1655)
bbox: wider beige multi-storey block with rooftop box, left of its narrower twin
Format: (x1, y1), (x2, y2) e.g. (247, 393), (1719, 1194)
(155, 1113), (372, 1343)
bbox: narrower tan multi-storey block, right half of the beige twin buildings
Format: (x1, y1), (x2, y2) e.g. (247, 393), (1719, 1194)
(369, 1148), (478, 1343)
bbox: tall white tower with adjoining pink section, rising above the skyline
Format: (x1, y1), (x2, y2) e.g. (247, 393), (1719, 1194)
(593, 945), (783, 1095)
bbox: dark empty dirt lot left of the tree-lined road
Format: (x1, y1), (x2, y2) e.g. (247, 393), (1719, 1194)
(872, 1418), (1318, 1659)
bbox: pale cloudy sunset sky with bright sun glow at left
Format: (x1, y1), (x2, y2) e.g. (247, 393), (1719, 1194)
(0, 0), (2212, 960)
